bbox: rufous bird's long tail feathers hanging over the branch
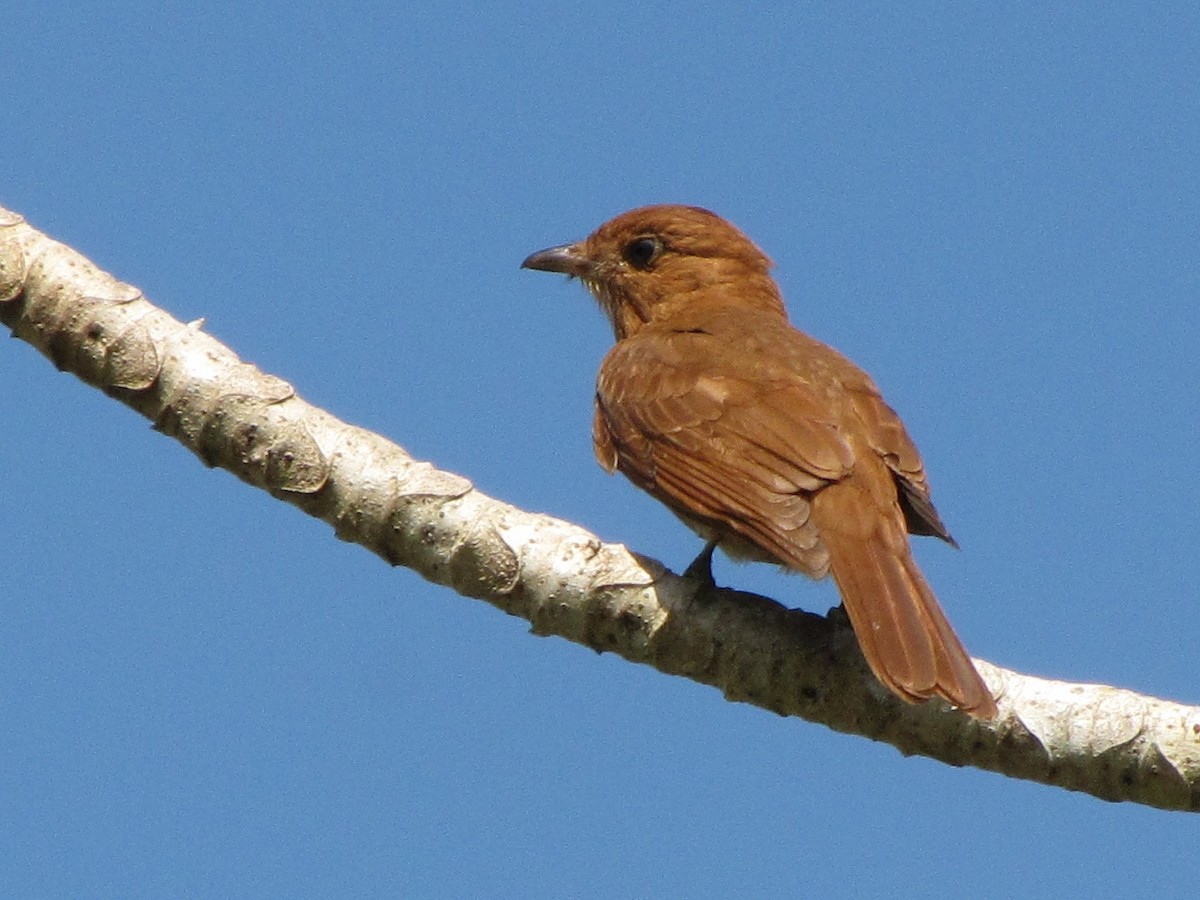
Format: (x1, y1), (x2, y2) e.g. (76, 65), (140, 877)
(822, 504), (996, 719)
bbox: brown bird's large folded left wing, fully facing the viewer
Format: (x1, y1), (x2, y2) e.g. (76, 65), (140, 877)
(594, 332), (854, 575)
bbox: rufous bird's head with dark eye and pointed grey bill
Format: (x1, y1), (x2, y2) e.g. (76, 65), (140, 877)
(521, 205), (786, 340)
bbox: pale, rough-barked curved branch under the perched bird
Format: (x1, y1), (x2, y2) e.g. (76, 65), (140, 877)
(0, 208), (1200, 811)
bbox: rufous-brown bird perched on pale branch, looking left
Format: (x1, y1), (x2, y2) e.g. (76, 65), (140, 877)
(522, 205), (996, 719)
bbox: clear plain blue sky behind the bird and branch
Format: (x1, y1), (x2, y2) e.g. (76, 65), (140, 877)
(0, 2), (1200, 898)
